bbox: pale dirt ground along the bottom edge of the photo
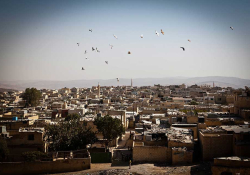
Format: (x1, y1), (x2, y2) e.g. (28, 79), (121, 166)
(51, 163), (212, 175)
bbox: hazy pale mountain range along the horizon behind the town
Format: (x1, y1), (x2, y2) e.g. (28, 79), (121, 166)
(0, 76), (250, 90)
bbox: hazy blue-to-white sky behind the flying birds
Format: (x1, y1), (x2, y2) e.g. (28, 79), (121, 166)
(0, 0), (250, 81)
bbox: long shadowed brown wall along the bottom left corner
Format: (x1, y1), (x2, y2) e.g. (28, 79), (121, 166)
(0, 157), (91, 175)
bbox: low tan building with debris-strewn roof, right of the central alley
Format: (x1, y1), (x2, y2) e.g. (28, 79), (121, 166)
(133, 125), (194, 164)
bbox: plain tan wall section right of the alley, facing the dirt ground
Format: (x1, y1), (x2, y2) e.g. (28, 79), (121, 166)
(133, 146), (172, 163)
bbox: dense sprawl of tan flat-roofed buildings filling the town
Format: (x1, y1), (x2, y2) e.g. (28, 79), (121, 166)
(0, 83), (250, 174)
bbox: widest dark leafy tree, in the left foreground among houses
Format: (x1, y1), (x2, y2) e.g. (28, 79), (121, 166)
(44, 115), (96, 151)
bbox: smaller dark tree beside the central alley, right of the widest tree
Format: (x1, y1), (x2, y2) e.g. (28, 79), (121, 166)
(94, 115), (125, 145)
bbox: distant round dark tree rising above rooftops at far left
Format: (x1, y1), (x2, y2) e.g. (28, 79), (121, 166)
(22, 88), (42, 107)
